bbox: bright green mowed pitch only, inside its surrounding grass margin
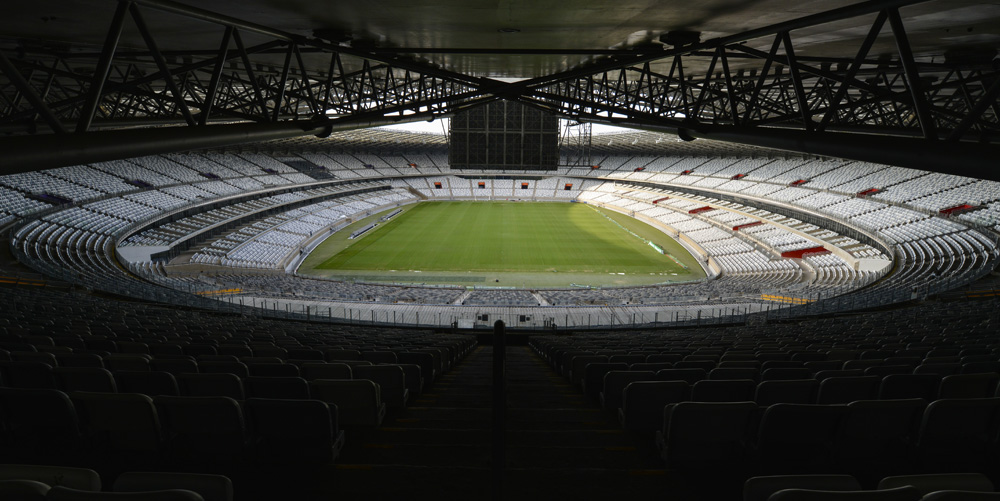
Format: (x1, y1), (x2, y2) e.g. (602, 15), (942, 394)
(317, 202), (683, 273)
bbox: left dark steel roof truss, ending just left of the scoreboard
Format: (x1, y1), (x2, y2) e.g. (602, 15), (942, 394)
(0, 0), (488, 134)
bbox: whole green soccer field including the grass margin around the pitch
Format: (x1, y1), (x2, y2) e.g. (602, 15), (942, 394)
(300, 202), (704, 287)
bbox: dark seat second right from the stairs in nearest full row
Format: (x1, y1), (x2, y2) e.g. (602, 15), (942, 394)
(756, 404), (847, 473)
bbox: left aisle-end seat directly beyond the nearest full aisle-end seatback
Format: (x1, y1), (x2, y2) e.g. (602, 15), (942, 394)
(309, 379), (385, 428)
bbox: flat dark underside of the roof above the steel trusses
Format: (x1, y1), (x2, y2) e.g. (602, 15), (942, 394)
(0, 0), (1000, 78)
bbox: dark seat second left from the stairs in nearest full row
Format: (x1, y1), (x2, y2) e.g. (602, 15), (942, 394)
(154, 396), (247, 470)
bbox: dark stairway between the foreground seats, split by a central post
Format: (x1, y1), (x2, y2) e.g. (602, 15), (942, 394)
(322, 346), (680, 500)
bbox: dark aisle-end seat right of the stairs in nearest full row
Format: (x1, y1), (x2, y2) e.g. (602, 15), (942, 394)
(659, 400), (757, 470)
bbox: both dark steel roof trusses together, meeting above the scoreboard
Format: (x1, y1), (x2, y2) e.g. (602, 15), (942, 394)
(0, 0), (1000, 178)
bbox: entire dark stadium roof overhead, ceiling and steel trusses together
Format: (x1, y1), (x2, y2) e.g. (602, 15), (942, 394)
(0, 0), (1000, 178)
